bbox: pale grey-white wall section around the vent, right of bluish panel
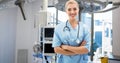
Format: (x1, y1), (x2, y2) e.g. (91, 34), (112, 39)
(15, 0), (42, 63)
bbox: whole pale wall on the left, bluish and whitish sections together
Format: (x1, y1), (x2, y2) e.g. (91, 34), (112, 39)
(0, 0), (42, 63)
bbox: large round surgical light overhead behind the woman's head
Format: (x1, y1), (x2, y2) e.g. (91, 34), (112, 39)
(55, 0), (120, 13)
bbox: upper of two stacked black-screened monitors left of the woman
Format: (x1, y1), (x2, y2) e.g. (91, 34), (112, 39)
(44, 27), (54, 41)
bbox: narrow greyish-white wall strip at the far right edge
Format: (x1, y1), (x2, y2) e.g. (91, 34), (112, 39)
(113, 7), (120, 56)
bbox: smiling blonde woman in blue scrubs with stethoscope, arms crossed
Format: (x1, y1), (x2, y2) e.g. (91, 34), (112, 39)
(52, 0), (90, 63)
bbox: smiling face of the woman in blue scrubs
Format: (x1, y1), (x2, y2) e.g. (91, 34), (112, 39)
(66, 3), (79, 19)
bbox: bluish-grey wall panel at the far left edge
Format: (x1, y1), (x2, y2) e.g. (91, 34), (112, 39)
(0, 8), (17, 63)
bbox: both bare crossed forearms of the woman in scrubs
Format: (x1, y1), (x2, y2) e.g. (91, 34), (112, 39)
(54, 41), (88, 55)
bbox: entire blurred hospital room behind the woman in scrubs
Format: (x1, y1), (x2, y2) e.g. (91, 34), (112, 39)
(0, 0), (120, 63)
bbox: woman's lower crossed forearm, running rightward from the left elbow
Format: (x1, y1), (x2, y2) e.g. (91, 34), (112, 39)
(54, 47), (75, 55)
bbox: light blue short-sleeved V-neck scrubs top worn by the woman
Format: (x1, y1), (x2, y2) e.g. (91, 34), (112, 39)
(52, 21), (91, 63)
